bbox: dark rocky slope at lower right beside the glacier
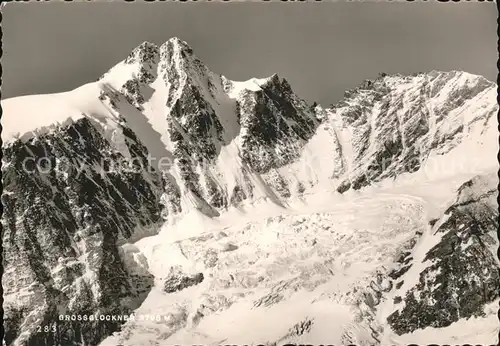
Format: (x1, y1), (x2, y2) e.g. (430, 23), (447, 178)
(387, 174), (500, 334)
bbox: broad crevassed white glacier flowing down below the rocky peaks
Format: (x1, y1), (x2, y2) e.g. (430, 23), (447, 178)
(102, 191), (426, 345)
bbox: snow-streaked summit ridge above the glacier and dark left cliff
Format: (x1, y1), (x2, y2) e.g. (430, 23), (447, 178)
(2, 38), (498, 211)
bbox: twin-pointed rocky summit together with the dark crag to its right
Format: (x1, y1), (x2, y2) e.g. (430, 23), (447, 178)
(103, 38), (319, 211)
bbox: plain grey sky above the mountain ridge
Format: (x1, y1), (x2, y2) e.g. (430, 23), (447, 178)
(1, 1), (498, 105)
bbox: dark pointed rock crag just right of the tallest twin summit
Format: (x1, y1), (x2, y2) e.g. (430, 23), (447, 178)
(238, 75), (319, 173)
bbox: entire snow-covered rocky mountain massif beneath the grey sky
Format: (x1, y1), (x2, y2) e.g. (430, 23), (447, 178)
(2, 38), (500, 345)
